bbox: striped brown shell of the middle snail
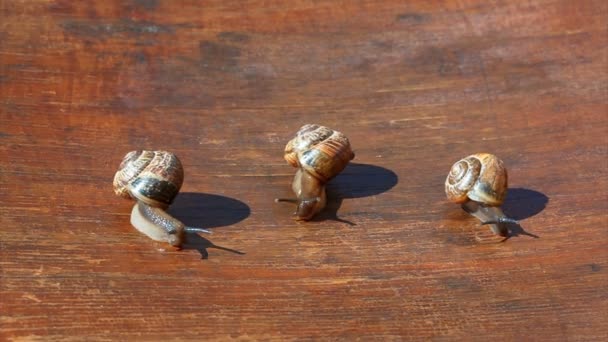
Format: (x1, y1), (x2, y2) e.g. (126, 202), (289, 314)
(284, 124), (355, 182)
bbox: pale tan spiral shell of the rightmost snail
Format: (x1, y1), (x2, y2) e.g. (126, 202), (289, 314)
(445, 153), (508, 206)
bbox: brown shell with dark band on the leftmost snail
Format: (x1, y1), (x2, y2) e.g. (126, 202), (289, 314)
(114, 151), (184, 208)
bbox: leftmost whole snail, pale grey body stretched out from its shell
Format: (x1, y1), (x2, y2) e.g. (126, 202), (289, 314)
(114, 151), (211, 248)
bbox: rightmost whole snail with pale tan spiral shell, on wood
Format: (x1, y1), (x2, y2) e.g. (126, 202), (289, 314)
(445, 153), (518, 237)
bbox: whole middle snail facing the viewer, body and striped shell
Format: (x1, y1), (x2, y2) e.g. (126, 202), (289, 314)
(275, 124), (355, 221)
